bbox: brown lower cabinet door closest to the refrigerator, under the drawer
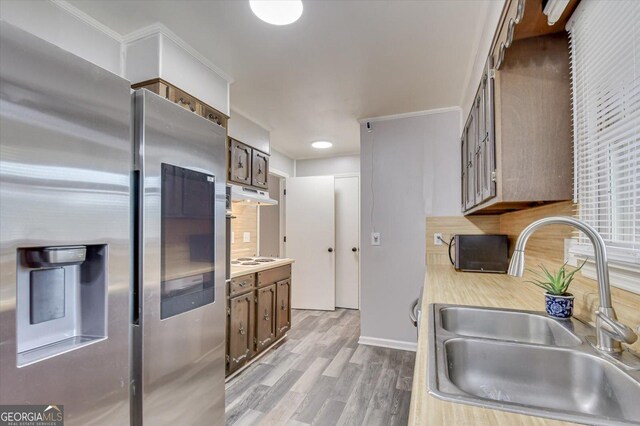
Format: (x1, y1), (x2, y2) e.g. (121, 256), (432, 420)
(227, 293), (255, 372)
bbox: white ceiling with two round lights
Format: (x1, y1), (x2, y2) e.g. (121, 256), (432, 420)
(66, 0), (491, 159)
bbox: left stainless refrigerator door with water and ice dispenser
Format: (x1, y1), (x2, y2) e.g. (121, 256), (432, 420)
(0, 22), (132, 425)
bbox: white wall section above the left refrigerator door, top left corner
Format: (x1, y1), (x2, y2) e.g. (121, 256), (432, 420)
(0, 0), (122, 75)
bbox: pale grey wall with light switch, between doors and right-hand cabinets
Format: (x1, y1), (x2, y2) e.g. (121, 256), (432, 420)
(360, 110), (460, 346)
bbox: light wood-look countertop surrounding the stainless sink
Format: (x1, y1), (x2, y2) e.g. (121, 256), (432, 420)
(409, 265), (570, 426)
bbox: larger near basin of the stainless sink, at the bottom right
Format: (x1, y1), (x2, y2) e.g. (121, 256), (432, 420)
(445, 338), (640, 422)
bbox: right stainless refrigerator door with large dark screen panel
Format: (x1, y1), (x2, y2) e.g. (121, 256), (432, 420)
(132, 89), (226, 426)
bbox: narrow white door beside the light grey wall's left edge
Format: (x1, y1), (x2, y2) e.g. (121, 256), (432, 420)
(335, 176), (360, 309)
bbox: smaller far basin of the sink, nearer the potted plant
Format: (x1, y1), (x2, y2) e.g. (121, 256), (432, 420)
(440, 307), (582, 346)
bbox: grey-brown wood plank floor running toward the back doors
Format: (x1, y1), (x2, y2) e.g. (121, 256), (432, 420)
(226, 309), (415, 426)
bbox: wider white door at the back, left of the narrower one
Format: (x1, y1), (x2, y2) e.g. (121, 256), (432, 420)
(285, 176), (336, 310)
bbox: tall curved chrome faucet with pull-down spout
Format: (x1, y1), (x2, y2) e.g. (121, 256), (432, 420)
(508, 216), (638, 354)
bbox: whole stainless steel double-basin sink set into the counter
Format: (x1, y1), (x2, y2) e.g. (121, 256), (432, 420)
(428, 304), (640, 425)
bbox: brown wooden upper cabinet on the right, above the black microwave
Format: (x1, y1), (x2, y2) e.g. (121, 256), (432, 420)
(461, 0), (573, 215)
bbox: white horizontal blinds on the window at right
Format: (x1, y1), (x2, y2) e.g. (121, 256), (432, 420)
(567, 0), (640, 253)
